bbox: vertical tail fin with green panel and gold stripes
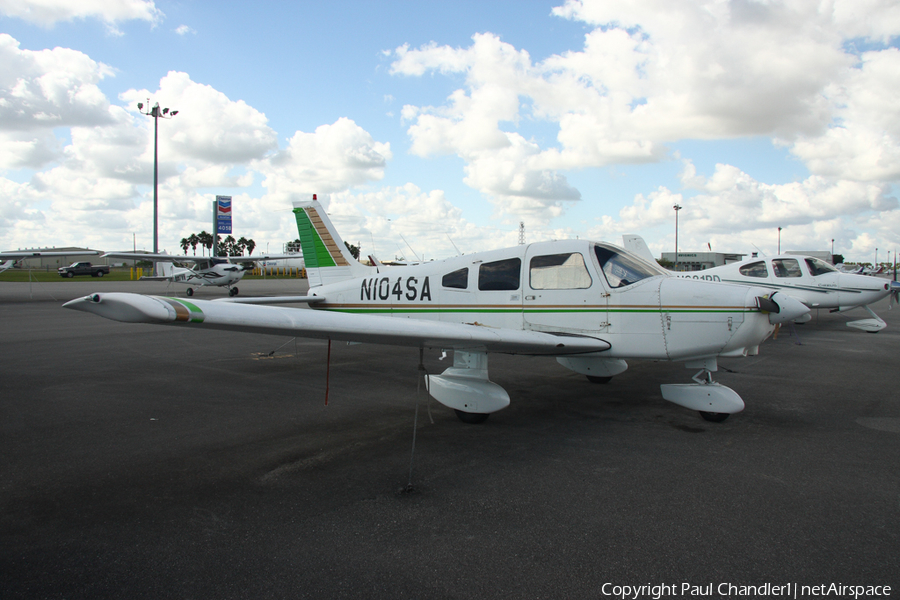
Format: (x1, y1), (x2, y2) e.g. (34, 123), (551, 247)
(294, 194), (375, 288)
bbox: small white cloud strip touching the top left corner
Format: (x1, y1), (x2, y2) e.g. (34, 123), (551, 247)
(0, 0), (163, 34)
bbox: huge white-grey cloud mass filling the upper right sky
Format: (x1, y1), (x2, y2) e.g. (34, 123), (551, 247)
(391, 0), (900, 239)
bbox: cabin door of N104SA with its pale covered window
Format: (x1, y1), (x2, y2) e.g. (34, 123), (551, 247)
(522, 245), (609, 333)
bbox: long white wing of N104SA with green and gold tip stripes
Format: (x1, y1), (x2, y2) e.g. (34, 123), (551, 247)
(63, 292), (610, 356)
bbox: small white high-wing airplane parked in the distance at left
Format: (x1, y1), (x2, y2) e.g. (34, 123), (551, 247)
(103, 252), (297, 296)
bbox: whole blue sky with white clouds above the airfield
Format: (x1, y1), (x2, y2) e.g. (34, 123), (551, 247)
(0, 0), (900, 261)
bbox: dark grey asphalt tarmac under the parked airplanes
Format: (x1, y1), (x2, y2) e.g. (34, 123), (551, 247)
(0, 279), (900, 600)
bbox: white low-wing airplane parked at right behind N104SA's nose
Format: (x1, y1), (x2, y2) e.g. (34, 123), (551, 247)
(623, 235), (897, 333)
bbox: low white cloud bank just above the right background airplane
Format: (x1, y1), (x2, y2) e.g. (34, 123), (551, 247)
(589, 162), (900, 253)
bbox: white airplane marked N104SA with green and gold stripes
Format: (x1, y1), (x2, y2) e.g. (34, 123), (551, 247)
(65, 200), (809, 422)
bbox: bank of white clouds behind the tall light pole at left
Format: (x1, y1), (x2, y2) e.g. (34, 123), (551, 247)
(0, 35), (391, 250)
